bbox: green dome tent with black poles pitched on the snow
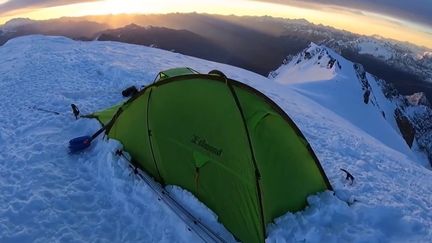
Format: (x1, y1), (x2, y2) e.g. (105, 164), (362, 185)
(93, 69), (331, 242)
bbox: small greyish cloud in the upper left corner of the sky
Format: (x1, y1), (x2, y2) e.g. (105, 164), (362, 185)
(0, 0), (100, 14)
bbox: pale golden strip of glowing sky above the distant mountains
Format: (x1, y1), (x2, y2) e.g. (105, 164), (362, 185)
(0, 0), (432, 49)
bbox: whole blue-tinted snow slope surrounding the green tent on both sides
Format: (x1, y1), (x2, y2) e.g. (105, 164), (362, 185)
(0, 36), (432, 242)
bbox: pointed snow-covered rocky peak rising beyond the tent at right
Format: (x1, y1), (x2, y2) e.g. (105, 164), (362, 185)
(270, 44), (432, 166)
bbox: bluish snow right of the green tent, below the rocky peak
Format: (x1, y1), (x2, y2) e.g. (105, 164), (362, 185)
(269, 87), (432, 242)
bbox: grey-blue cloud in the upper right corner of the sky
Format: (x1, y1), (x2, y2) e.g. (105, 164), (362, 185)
(254, 0), (432, 27)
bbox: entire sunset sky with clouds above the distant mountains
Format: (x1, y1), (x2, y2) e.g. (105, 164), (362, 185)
(0, 0), (432, 48)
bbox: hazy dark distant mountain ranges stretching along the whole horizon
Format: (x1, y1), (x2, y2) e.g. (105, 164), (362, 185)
(0, 13), (432, 100)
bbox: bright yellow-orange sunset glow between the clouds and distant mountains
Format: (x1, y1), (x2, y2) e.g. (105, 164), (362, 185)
(0, 0), (432, 48)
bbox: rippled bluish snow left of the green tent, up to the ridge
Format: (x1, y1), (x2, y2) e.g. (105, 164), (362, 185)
(0, 36), (243, 242)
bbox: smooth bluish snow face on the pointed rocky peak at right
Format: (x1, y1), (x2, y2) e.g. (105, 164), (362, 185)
(274, 45), (411, 161)
